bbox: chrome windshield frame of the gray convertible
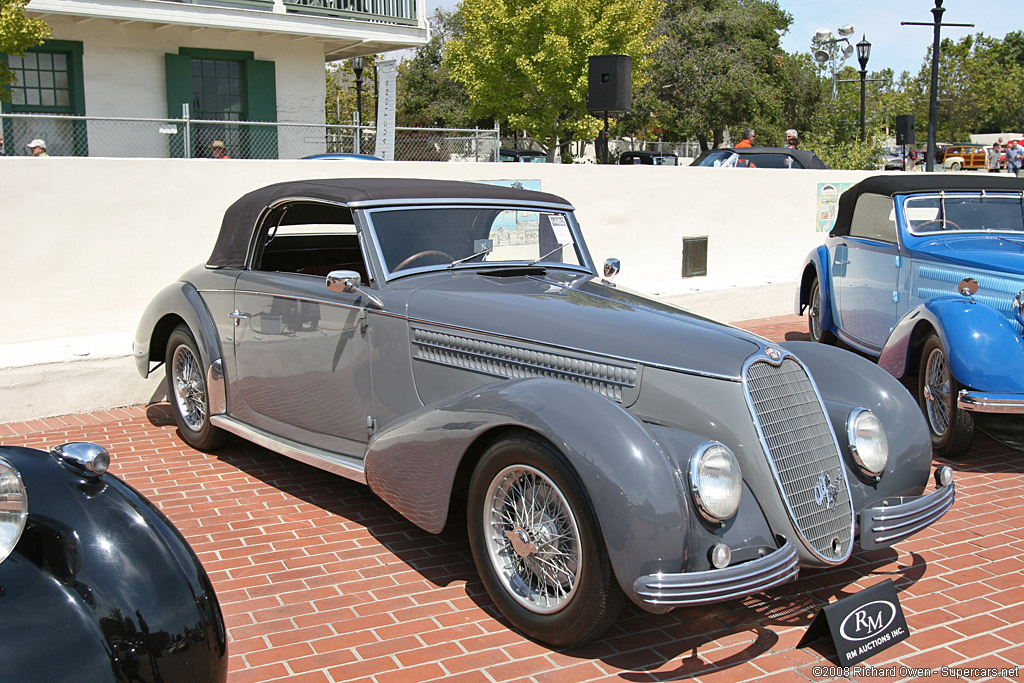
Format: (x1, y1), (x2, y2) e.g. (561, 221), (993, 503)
(359, 200), (597, 282)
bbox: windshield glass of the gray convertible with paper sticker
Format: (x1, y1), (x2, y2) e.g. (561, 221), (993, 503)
(368, 207), (586, 275)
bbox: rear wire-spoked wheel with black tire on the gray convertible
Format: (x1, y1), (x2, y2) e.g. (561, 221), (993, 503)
(164, 325), (225, 451)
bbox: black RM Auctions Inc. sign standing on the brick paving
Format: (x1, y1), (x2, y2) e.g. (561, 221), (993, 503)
(801, 579), (910, 667)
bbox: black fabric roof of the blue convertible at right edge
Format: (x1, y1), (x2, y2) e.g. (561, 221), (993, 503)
(829, 173), (1024, 237)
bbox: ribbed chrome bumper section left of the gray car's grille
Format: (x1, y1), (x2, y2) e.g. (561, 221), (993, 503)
(633, 539), (800, 605)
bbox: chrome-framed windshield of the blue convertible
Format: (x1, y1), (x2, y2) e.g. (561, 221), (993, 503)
(903, 193), (1024, 234)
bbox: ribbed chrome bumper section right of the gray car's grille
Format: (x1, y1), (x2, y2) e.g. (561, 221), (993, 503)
(859, 481), (956, 550)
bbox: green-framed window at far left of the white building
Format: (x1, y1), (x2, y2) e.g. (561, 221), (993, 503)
(0, 40), (89, 157)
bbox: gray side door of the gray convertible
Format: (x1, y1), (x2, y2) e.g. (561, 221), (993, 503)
(232, 220), (373, 456)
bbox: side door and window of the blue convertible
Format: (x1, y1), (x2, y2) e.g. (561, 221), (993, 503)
(833, 195), (902, 353)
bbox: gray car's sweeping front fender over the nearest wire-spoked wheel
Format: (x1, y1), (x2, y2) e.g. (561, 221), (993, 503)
(366, 379), (689, 600)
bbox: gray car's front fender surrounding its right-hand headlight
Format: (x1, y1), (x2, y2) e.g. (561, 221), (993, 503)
(782, 342), (932, 505)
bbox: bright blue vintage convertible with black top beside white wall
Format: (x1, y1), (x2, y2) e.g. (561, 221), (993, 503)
(797, 175), (1024, 457)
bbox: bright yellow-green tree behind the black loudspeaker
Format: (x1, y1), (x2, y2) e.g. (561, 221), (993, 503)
(442, 0), (663, 159)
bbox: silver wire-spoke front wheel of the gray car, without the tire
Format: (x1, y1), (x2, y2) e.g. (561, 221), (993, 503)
(483, 465), (581, 614)
